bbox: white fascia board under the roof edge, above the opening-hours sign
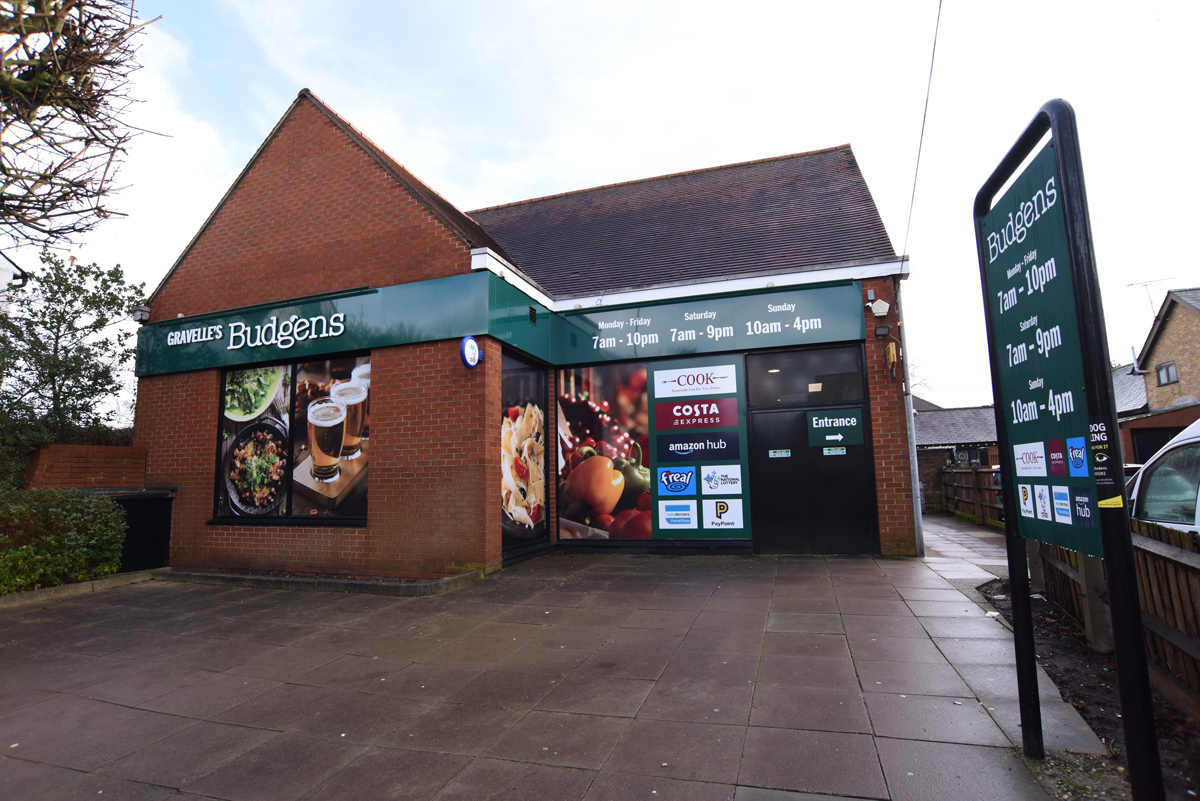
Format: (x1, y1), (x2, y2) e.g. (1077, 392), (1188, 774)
(470, 247), (908, 312)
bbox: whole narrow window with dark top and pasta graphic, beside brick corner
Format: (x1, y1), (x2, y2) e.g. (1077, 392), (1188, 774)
(500, 352), (554, 548)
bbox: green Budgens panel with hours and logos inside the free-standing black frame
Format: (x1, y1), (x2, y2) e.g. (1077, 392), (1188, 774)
(982, 141), (1099, 555)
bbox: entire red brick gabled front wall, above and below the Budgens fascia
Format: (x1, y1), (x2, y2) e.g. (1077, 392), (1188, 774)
(134, 100), (500, 577)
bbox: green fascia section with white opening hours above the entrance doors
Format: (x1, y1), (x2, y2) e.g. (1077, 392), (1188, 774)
(550, 282), (866, 365)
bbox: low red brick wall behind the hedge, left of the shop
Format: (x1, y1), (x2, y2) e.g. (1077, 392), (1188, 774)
(26, 445), (146, 489)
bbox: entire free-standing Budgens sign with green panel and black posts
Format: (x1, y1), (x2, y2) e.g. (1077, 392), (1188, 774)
(974, 100), (1163, 801)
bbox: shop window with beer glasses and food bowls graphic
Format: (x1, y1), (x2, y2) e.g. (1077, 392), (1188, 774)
(214, 354), (371, 523)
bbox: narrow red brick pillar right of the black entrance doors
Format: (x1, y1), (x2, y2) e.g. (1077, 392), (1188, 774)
(863, 278), (917, 556)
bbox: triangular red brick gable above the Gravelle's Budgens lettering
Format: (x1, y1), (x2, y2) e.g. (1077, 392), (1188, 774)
(150, 100), (470, 321)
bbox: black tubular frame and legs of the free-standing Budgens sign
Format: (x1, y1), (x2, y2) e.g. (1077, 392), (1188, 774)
(973, 100), (1163, 801)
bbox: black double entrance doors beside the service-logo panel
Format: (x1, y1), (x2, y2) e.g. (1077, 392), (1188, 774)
(750, 406), (880, 554)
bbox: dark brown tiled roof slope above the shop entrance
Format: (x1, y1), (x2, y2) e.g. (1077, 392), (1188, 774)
(468, 145), (896, 297)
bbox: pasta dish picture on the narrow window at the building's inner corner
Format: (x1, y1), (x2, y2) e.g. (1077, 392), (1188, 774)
(500, 403), (546, 535)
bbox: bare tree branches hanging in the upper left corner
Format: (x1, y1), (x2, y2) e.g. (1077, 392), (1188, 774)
(0, 0), (154, 245)
